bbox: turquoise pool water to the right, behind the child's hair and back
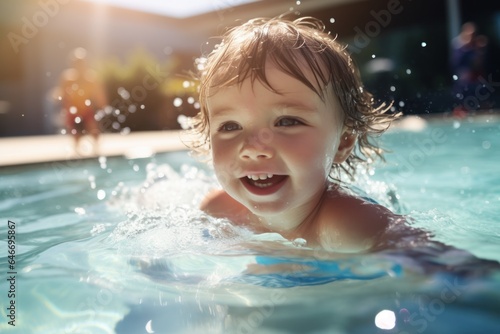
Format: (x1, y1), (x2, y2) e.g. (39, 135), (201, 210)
(372, 116), (500, 260)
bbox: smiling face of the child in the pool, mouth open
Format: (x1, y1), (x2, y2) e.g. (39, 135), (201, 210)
(207, 64), (350, 216)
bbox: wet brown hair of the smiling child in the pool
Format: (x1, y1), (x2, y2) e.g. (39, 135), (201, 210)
(191, 17), (399, 178)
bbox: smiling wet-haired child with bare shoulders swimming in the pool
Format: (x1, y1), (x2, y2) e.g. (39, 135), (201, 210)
(188, 18), (399, 252)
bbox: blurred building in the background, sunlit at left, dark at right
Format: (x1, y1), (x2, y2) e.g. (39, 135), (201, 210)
(0, 0), (500, 136)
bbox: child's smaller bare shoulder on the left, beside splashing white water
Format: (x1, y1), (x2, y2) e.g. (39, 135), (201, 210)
(200, 189), (247, 221)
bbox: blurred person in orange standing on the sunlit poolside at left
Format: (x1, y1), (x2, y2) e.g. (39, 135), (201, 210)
(56, 47), (108, 154)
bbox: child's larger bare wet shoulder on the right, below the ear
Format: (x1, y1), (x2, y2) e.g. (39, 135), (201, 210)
(320, 190), (399, 250)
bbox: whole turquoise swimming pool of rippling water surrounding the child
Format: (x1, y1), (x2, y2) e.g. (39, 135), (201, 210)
(0, 115), (500, 334)
